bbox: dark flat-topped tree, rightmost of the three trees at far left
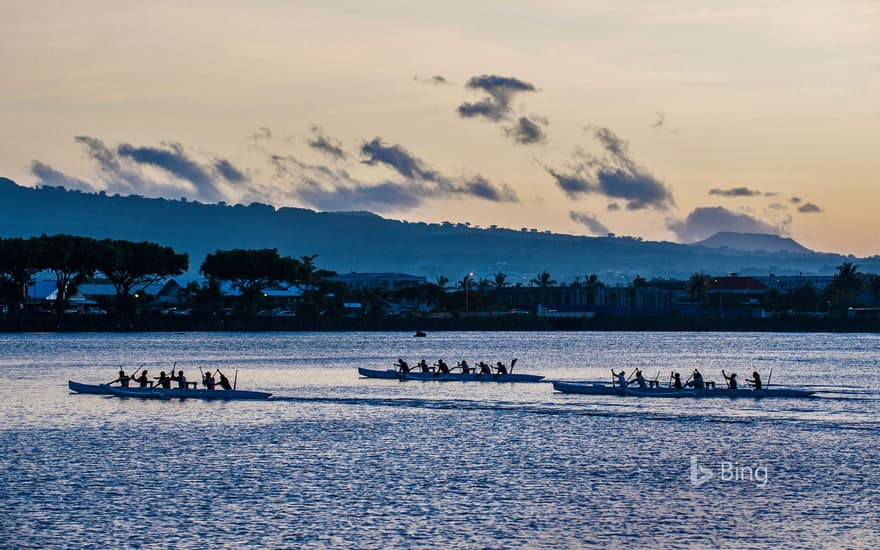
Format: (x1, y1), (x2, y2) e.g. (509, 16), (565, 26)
(97, 239), (189, 315)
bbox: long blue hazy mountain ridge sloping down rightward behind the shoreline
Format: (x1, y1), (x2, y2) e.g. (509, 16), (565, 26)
(0, 178), (880, 286)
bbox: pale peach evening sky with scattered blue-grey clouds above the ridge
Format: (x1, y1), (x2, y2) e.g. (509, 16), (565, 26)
(0, 0), (880, 256)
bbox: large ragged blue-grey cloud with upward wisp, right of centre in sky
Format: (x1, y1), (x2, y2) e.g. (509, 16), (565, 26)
(544, 128), (675, 210)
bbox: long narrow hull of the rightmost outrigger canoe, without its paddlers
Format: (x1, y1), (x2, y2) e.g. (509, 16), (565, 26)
(553, 382), (815, 398)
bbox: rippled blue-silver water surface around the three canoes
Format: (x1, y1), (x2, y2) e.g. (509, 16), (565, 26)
(0, 332), (880, 548)
